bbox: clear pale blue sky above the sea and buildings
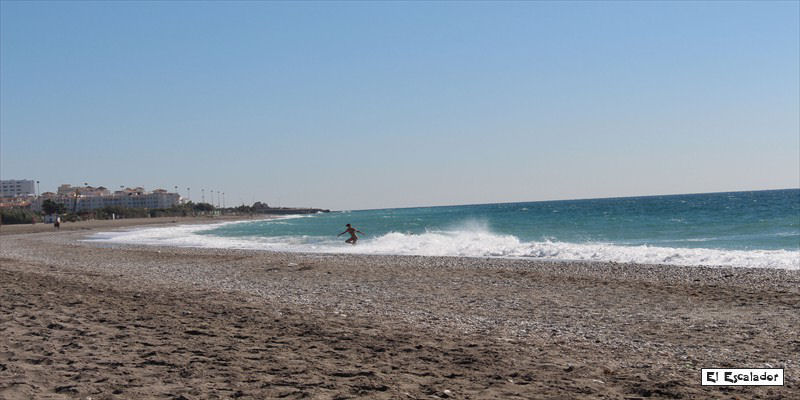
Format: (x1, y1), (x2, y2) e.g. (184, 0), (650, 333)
(0, 1), (800, 209)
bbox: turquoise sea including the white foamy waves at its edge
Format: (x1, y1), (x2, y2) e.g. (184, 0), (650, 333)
(89, 189), (800, 270)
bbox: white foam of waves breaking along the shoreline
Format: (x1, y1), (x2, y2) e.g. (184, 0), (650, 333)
(89, 222), (800, 270)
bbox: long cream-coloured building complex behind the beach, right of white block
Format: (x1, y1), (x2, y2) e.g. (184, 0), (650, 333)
(31, 184), (181, 212)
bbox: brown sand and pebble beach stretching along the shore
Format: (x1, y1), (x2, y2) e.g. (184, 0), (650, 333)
(0, 218), (800, 400)
